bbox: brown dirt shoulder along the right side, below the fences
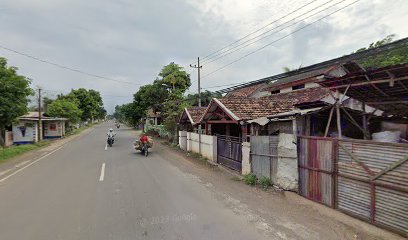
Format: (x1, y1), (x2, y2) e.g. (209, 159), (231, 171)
(153, 140), (404, 240)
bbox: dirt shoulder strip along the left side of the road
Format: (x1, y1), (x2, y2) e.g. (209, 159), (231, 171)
(0, 125), (97, 179)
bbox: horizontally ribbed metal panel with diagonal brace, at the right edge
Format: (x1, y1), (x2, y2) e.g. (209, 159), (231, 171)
(337, 140), (408, 235)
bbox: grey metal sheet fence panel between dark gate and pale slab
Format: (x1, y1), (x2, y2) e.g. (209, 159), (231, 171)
(251, 136), (279, 183)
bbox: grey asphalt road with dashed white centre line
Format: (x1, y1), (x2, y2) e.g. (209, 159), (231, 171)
(0, 123), (265, 240)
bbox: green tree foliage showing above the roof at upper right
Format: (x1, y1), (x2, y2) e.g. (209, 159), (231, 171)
(356, 34), (408, 68)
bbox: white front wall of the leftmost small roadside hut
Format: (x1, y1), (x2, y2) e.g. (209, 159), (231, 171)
(13, 120), (38, 144)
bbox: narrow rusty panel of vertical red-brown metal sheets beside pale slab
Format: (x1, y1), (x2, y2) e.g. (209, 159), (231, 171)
(298, 136), (335, 207)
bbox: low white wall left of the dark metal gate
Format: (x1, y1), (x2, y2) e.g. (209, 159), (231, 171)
(187, 132), (217, 161)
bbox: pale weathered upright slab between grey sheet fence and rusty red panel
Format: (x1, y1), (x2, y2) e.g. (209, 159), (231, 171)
(276, 133), (299, 191)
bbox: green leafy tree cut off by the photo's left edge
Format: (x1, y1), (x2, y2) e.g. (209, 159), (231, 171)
(0, 57), (33, 144)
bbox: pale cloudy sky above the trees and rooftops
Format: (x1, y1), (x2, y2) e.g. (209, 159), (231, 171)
(0, 0), (408, 113)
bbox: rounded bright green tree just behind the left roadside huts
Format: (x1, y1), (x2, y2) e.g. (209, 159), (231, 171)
(47, 99), (82, 123)
